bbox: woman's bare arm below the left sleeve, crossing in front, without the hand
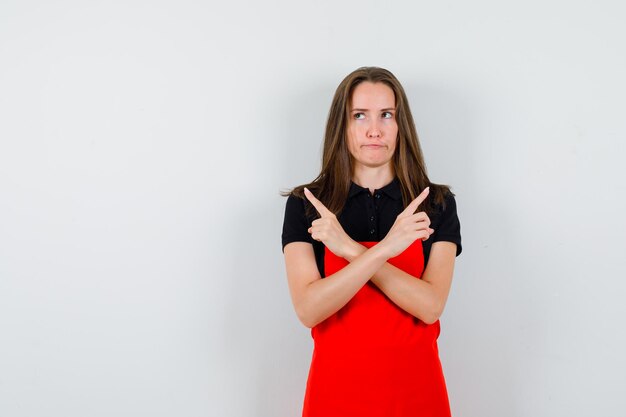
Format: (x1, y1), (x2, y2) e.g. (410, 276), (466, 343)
(284, 242), (388, 327)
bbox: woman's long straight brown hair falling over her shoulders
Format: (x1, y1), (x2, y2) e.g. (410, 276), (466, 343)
(282, 67), (450, 217)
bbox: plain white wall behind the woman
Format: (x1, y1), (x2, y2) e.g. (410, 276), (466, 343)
(0, 0), (626, 417)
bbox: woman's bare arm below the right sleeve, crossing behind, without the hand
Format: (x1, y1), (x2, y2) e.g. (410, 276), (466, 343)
(348, 241), (456, 324)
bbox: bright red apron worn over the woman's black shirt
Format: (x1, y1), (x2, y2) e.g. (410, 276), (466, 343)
(302, 240), (450, 417)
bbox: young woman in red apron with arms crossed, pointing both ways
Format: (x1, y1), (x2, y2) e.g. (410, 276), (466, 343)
(282, 67), (461, 417)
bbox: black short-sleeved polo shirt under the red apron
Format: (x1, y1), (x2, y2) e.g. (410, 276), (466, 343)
(282, 178), (462, 277)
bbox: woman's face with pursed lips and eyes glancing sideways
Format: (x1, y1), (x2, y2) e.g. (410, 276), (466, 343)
(347, 81), (398, 169)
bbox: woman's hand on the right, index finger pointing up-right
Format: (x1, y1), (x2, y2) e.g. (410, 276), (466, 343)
(379, 187), (434, 258)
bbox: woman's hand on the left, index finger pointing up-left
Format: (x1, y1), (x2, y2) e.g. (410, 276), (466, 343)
(304, 188), (358, 258)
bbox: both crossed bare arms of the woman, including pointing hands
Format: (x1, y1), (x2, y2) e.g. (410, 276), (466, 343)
(284, 189), (456, 327)
